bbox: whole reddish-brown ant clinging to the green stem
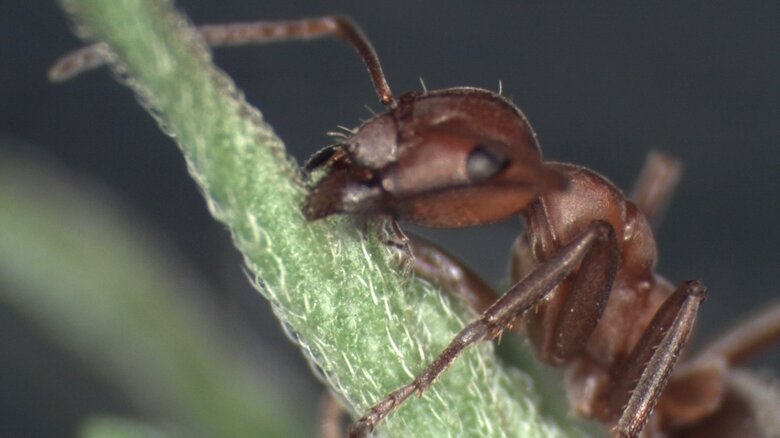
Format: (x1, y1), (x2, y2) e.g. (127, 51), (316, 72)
(50, 16), (780, 438)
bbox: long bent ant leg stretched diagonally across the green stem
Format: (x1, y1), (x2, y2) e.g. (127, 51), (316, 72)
(350, 221), (617, 437)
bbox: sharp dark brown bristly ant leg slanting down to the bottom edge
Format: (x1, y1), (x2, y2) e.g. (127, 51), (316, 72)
(606, 281), (707, 438)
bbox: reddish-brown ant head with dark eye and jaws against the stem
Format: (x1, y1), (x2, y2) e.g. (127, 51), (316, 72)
(304, 88), (565, 227)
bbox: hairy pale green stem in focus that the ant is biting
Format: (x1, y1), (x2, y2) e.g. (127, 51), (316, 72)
(59, 0), (584, 437)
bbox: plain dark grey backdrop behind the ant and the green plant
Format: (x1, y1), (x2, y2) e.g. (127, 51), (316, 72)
(0, 0), (780, 436)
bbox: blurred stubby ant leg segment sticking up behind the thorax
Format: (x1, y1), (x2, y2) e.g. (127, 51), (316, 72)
(631, 151), (682, 228)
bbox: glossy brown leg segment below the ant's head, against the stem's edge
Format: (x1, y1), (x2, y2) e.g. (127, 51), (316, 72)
(408, 235), (496, 313)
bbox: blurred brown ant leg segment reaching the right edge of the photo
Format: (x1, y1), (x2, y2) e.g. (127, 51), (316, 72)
(695, 302), (780, 365)
